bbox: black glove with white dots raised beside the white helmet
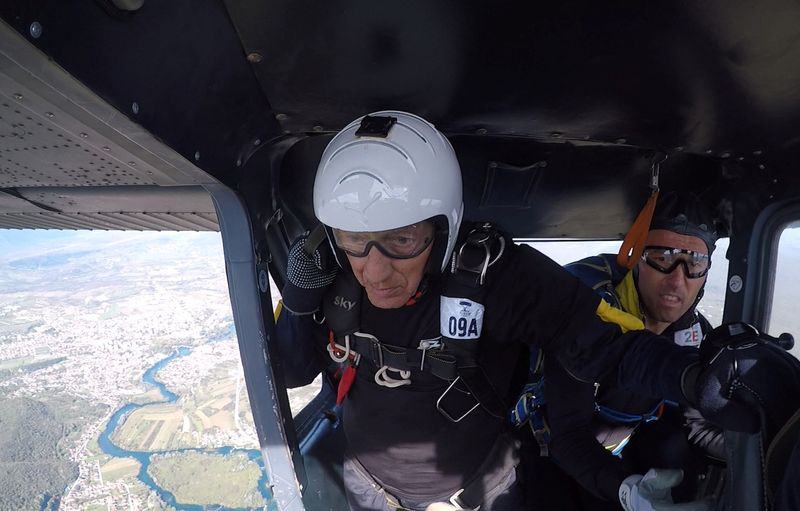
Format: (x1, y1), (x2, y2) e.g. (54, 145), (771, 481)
(282, 227), (338, 314)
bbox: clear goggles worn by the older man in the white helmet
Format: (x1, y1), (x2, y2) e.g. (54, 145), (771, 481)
(331, 220), (435, 259)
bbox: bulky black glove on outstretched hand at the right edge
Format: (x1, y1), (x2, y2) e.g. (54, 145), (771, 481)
(683, 323), (800, 433)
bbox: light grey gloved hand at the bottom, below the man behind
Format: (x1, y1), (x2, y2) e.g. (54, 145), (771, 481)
(619, 468), (712, 511)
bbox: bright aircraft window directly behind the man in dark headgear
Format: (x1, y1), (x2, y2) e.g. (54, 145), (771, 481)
(527, 238), (728, 326)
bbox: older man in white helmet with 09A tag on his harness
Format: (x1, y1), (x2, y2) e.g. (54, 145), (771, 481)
(278, 111), (792, 511)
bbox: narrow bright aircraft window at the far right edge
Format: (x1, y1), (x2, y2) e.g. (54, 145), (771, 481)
(767, 222), (800, 358)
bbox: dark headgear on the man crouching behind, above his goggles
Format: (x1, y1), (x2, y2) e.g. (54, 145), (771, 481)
(650, 192), (717, 255)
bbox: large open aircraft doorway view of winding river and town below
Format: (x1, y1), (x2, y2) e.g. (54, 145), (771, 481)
(0, 231), (286, 510)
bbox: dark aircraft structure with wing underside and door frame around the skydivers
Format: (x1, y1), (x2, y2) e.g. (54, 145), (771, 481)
(0, 0), (800, 511)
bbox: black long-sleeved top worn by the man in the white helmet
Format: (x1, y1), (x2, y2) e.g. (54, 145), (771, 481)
(278, 241), (696, 506)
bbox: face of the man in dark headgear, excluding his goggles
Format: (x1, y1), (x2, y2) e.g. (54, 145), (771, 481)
(638, 229), (708, 328)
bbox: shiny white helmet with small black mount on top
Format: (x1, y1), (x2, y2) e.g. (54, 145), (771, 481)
(314, 111), (464, 270)
